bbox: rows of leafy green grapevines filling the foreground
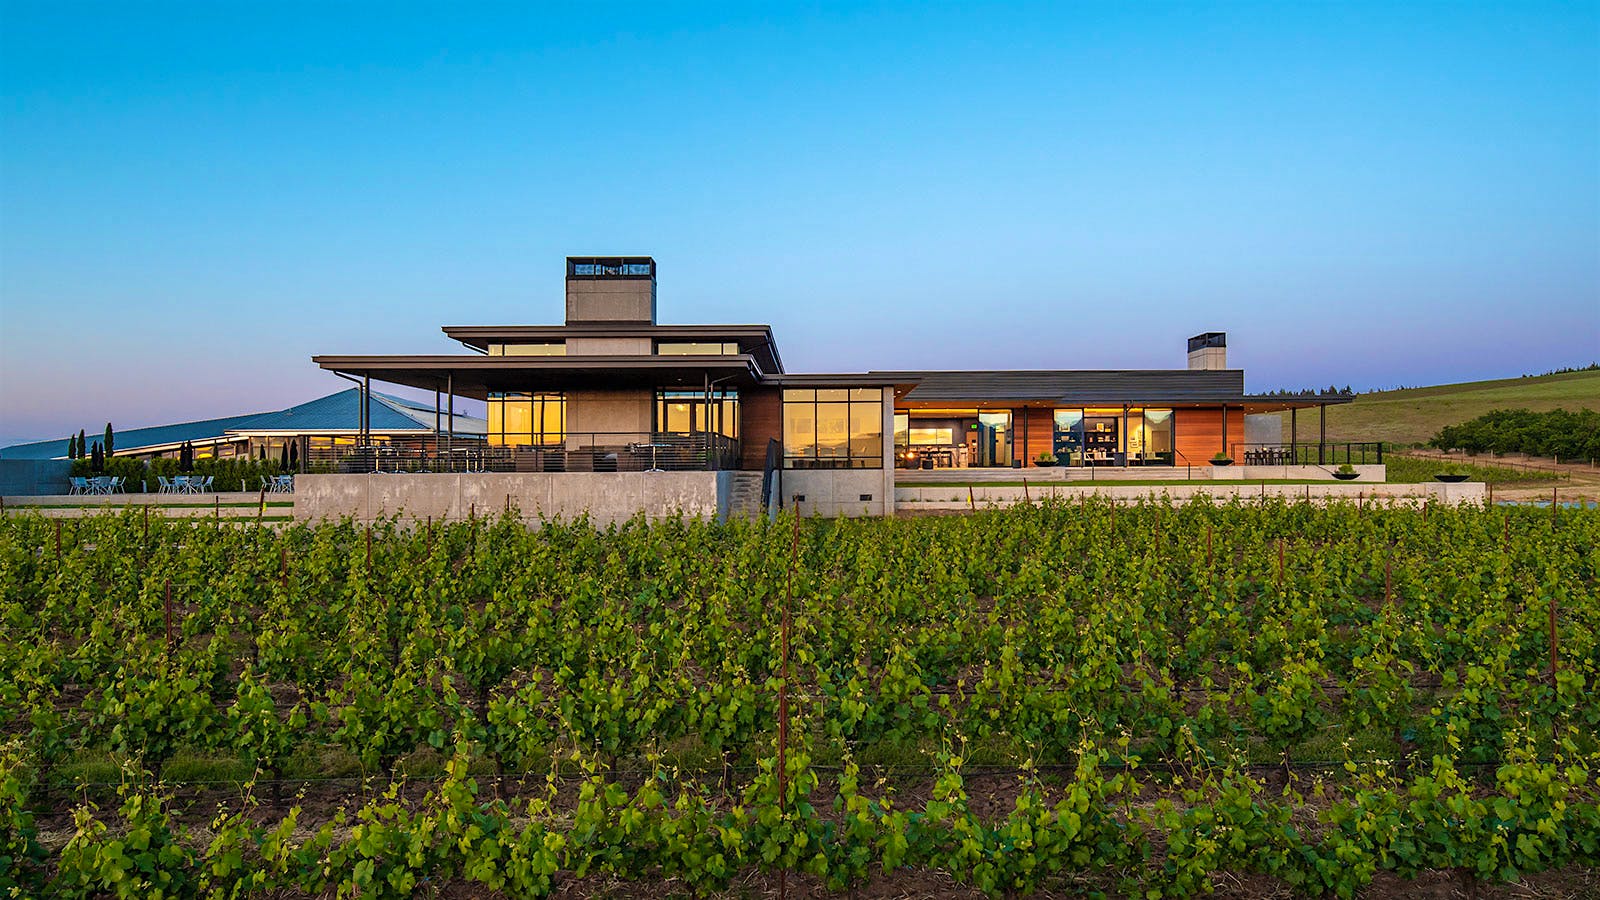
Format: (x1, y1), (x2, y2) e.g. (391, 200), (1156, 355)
(0, 501), (1600, 898)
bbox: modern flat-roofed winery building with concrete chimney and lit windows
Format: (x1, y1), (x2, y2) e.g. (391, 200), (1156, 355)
(297, 256), (1349, 514)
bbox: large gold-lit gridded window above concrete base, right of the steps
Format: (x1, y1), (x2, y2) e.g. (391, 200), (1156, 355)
(784, 388), (883, 469)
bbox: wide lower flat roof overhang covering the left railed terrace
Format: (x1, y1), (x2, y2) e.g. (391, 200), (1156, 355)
(312, 354), (762, 400)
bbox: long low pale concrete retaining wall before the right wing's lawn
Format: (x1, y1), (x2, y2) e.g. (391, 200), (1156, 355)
(894, 482), (1486, 512)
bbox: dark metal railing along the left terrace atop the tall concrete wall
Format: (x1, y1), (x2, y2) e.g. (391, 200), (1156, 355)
(307, 431), (739, 474)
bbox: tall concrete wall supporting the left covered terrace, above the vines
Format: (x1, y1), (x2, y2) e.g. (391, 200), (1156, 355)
(294, 472), (734, 525)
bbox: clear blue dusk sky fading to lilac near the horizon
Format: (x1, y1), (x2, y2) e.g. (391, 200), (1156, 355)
(0, 0), (1600, 445)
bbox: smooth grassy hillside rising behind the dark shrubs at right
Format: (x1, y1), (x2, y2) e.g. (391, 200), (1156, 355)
(1283, 372), (1600, 444)
